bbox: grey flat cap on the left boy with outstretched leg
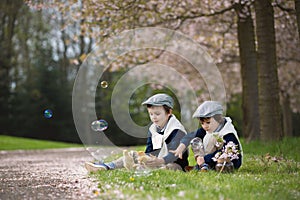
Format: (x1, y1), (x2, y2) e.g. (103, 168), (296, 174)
(142, 93), (174, 108)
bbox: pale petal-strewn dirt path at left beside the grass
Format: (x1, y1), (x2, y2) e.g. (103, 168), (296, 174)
(0, 148), (120, 200)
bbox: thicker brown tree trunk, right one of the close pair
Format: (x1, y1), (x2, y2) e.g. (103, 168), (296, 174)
(254, 0), (283, 141)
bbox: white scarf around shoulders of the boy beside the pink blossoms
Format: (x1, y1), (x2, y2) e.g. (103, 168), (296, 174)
(203, 117), (243, 158)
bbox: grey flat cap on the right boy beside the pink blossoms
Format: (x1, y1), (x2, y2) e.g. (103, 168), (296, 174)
(193, 101), (223, 118)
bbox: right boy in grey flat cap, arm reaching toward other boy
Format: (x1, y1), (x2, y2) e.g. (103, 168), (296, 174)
(171, 101), (243, 171)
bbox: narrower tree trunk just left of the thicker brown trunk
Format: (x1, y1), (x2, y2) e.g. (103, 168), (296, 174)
(236, 5), (259, 141)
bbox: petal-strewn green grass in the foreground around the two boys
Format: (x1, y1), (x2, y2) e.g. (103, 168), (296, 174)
(91, 138), (300, 200)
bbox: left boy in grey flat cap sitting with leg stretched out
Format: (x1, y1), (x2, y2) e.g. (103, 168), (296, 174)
(85, 93), (188, 171)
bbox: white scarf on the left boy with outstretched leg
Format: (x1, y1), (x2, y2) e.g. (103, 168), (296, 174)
(149, 114), (186, 158)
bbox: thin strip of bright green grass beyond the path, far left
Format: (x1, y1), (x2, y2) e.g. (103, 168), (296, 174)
(0, 135), (82, 150)
